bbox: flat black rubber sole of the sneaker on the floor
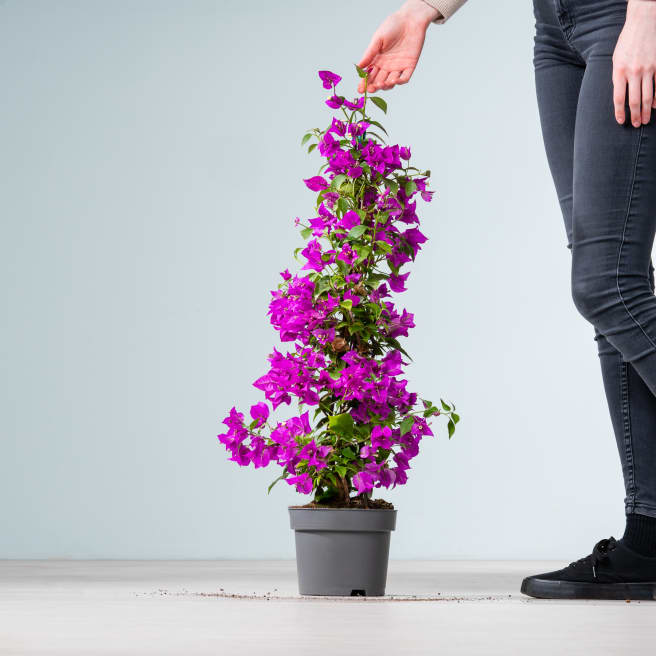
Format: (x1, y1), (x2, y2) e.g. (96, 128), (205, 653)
(521, 578), (656, 601)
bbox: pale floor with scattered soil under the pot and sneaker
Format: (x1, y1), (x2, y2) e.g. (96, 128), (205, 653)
(0, 561), (656, 656)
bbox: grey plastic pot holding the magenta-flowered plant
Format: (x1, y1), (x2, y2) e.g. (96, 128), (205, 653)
(289, 507), (396, 597)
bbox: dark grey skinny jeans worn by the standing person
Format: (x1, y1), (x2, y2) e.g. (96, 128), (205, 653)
(533, 0), (656, 517)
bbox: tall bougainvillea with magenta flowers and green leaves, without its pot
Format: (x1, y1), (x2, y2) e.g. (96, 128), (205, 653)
(218, 66), (459, 507)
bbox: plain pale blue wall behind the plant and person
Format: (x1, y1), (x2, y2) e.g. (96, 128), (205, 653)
(0, 0), (623, 559)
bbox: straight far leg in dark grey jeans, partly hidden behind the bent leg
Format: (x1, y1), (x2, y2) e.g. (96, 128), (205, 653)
(534, 0), (656, 514)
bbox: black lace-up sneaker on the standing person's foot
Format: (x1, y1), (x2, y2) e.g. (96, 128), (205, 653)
(521, 537), (656, 599)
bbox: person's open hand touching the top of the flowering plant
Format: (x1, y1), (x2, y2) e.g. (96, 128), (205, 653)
(358, 0), (440, 93)
